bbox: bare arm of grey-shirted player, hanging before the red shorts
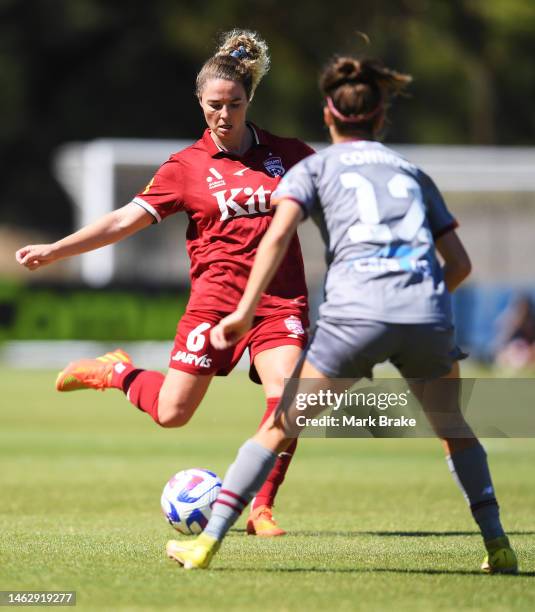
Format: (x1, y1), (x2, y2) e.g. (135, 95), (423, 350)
(210, 198), (304, 350)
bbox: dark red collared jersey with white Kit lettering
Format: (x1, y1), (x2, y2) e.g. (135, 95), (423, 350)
(133, 124), (314, 316)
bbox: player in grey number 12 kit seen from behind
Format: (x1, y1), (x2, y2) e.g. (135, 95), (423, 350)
(167, 57), (517, 573)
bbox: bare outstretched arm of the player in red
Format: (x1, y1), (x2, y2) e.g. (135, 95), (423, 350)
(15, 202), (153, 270)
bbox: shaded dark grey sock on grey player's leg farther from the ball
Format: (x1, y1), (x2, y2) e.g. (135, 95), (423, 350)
(446, 442), (505, 540)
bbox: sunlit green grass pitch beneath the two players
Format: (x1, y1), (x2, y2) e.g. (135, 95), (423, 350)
(0, 370), (535, 612)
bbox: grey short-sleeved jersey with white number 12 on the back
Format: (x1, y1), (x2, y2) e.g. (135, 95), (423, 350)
(272, 141), (456, 324)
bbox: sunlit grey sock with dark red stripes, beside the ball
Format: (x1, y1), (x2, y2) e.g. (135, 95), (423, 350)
(204, 440), (277, 540)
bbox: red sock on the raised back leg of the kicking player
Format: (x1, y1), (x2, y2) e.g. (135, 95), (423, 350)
(111, 364), (165, 425)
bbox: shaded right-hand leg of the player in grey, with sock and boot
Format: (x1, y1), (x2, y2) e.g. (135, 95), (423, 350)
(405, 330), (518, 573)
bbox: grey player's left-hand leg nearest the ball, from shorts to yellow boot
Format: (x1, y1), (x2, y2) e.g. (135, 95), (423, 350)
(167, 321), (389, 569)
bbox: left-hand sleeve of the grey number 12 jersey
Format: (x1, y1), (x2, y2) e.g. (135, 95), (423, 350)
(271, 155), (320, 217)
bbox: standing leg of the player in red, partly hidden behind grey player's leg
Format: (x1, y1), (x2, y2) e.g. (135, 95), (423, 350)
(247, 345), (301, 537)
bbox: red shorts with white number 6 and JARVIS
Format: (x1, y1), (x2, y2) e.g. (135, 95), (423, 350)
(169, 310), (308, 383)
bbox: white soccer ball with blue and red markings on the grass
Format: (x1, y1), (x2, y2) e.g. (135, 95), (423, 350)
(161, 468), (221, 535)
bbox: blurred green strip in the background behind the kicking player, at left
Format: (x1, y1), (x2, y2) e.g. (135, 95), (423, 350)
(0, 283), (188, 341)
